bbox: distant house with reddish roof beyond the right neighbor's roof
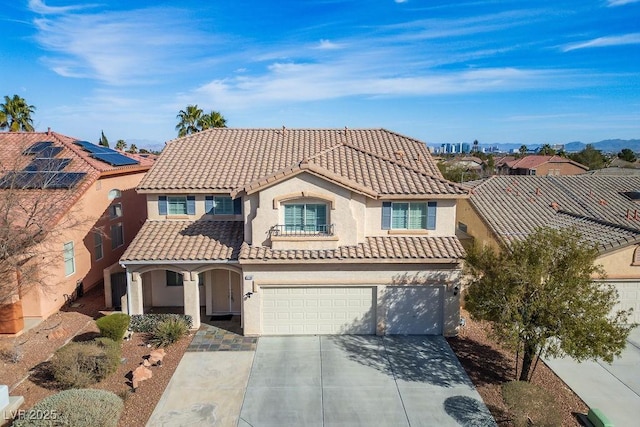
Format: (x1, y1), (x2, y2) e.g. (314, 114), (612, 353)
(496, 156), (589, 176)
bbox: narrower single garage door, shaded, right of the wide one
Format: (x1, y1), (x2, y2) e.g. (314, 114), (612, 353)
(383, 286), (444, 335)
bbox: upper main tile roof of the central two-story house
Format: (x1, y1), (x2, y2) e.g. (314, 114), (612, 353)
(138, 128), (466, 196)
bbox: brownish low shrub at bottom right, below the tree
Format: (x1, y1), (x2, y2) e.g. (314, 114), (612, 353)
(502, 381), (562, 427)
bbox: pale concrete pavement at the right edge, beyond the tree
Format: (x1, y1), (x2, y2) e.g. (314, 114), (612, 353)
(545, 328), (640, 427)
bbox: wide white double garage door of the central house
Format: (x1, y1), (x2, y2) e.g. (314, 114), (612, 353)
(261, 287), (375, 335)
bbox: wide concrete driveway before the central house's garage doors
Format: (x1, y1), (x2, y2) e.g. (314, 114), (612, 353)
(238, 335), (495, 427)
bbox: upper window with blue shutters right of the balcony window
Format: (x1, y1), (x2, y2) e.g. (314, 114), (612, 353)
(382, 202), (437, 230)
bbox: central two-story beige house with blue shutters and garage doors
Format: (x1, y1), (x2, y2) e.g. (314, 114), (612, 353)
(121, 128), (468, 335)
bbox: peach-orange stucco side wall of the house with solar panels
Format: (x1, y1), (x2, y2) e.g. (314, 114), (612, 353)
(22, 173), (147, 318)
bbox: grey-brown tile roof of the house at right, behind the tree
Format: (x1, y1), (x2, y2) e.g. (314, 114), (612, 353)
(470, 175), (640, 251)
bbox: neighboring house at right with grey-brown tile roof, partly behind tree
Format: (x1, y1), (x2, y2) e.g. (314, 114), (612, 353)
(458, 174), (640, 322)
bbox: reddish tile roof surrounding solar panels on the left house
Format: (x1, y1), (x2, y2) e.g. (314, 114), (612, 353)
(0, 131), (153, 227)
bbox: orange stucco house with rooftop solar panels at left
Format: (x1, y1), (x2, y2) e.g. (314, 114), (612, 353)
(0, 131), (153, 333)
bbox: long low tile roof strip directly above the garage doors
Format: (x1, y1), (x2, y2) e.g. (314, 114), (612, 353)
(240, 236), (464, 263)
